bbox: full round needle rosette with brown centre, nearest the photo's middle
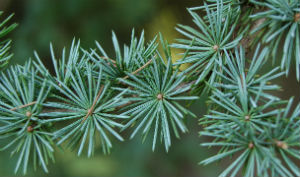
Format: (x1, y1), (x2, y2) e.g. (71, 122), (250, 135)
(117, 38), (198, 151)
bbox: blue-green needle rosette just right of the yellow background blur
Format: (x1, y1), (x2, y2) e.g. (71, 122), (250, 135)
(172, 0), (243, 84)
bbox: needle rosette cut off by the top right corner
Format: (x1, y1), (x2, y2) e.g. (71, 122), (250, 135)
(251, 0), (300, 81)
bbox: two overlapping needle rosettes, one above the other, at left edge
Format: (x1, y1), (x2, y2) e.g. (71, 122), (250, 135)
(0, 66), (54, 174)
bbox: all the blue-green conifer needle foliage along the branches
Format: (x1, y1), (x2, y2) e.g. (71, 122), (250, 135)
(0, 0), (300, 177)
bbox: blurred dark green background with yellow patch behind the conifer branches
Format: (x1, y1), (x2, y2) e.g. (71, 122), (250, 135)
(0, 0), (300, 177)
